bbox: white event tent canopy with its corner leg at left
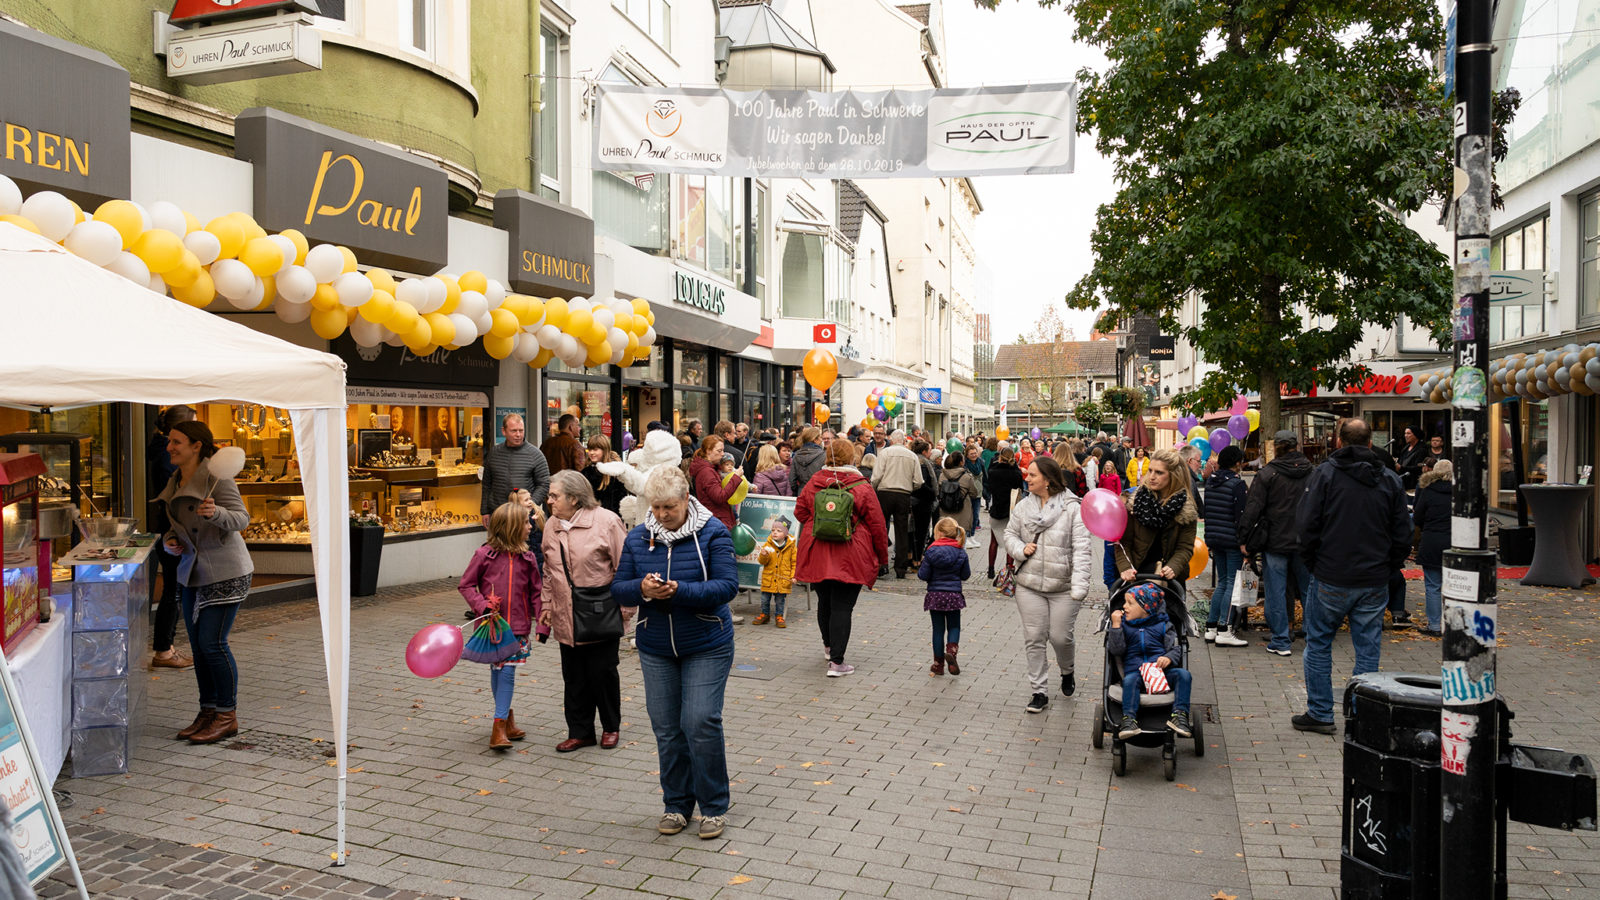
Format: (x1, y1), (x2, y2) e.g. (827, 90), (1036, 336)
(0, 223), (350, 865)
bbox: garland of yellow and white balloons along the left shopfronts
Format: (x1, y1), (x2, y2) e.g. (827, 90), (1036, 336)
(0, 175), (656, 368)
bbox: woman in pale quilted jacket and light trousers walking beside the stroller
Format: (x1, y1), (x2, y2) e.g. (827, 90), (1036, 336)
(1005, 456), (1093, 713)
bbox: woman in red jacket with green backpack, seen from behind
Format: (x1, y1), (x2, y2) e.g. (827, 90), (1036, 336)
(795, 440), (890, 677)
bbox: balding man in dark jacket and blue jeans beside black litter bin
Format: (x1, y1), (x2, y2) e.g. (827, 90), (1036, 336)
(1293, 418), (1411, 735)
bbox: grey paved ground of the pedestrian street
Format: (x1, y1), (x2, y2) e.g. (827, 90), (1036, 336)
(34, 534), (1600, 900)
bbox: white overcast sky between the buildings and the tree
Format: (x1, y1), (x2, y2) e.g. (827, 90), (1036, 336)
(944, 0), (1117, 343)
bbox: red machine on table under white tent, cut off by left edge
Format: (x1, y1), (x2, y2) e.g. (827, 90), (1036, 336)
(0, 453), (50, 653)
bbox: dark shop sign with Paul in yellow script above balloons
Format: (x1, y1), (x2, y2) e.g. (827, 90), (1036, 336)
(234, 107), (450, 275)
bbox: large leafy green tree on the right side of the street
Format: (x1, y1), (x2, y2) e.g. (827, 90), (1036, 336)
(976, 0), (1451, 434)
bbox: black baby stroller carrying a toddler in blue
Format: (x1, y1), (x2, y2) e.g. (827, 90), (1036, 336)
(1091, 575), (1205, 781)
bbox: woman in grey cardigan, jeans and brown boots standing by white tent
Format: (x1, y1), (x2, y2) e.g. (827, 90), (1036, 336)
(157, 421), (254, 743)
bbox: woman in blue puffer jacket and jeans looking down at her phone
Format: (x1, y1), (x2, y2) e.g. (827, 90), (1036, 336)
(611, 466), (739, 839)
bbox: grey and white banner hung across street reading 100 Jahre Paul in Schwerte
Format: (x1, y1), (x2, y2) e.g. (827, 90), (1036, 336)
(594, 83), (1077, 178)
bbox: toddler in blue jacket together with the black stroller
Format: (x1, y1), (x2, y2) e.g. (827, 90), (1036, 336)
(1093, 577), (1205, 780)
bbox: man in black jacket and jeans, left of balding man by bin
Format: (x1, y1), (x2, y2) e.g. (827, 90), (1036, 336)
(1238, 431), (1312, 657)
